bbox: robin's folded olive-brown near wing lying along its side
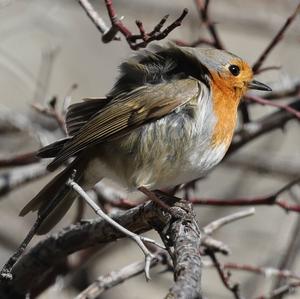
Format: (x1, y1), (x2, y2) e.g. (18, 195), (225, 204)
(48, 78), (200, 170)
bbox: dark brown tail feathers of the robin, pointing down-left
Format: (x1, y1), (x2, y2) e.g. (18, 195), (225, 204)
(19, 159), (83, 235)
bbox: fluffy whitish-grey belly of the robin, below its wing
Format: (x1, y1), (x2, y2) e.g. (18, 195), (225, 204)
(82, 89), (227, 191)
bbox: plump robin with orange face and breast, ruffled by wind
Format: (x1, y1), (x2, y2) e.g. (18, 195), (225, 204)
(20, 44), (271, 234)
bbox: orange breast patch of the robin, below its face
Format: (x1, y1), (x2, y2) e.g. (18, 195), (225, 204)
(212, 75), (240, 147)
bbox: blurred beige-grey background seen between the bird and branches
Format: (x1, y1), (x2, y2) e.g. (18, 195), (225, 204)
(0, 0), (300, 299)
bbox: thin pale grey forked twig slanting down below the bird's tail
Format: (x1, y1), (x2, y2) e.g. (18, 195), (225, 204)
(67, 179), (164, 280)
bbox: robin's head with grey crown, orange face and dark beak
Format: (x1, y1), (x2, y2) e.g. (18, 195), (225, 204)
(193, 48), (271, 97)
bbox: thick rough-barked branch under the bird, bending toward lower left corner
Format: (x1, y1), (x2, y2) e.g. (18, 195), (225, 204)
(0, 198), (201, 299)
